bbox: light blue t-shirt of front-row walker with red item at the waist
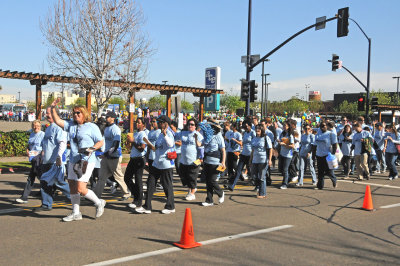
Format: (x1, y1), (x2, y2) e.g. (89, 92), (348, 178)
(153, 130), (175, 169)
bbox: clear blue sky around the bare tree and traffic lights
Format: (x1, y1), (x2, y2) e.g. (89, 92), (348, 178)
(0, 0), (400, 100)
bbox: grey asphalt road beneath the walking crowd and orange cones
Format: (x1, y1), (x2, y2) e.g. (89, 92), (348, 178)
(0, 167), (400, 265)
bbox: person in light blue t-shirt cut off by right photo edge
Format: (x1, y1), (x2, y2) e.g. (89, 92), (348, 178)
(383, 124), (400, 180)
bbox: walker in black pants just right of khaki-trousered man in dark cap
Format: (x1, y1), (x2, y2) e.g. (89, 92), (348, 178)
(124, 117), (147, 209)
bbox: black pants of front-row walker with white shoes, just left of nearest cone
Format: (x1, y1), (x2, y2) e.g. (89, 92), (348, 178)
(143, 167), (175, 210)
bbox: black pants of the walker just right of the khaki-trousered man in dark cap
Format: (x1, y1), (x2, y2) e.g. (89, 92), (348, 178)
(124, 157), (145, 207)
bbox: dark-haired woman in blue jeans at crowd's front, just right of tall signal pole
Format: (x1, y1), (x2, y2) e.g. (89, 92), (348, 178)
(250, 125), (272, 199)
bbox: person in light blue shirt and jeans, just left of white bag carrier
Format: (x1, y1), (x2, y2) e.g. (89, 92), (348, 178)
(296, 124), (317, 186)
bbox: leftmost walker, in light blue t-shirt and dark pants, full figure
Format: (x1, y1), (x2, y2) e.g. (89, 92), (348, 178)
(15, 120), (44, 203)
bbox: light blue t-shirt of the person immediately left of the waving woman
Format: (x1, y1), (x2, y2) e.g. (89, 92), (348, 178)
(42, 123), (67, 164)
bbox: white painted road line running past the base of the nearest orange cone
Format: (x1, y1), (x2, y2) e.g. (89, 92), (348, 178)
(87, 225), (293, 266)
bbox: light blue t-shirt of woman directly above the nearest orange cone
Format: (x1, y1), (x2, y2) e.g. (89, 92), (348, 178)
(176, 131), (203, 165)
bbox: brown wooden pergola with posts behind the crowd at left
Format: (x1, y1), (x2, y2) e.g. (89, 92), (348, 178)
(0, 69), (224, 132)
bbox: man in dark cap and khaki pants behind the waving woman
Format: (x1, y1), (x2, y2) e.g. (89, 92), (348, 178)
(94, 111), (131, 200)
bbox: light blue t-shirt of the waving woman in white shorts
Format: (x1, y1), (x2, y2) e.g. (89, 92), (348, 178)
(64, 120), (103, 163)
